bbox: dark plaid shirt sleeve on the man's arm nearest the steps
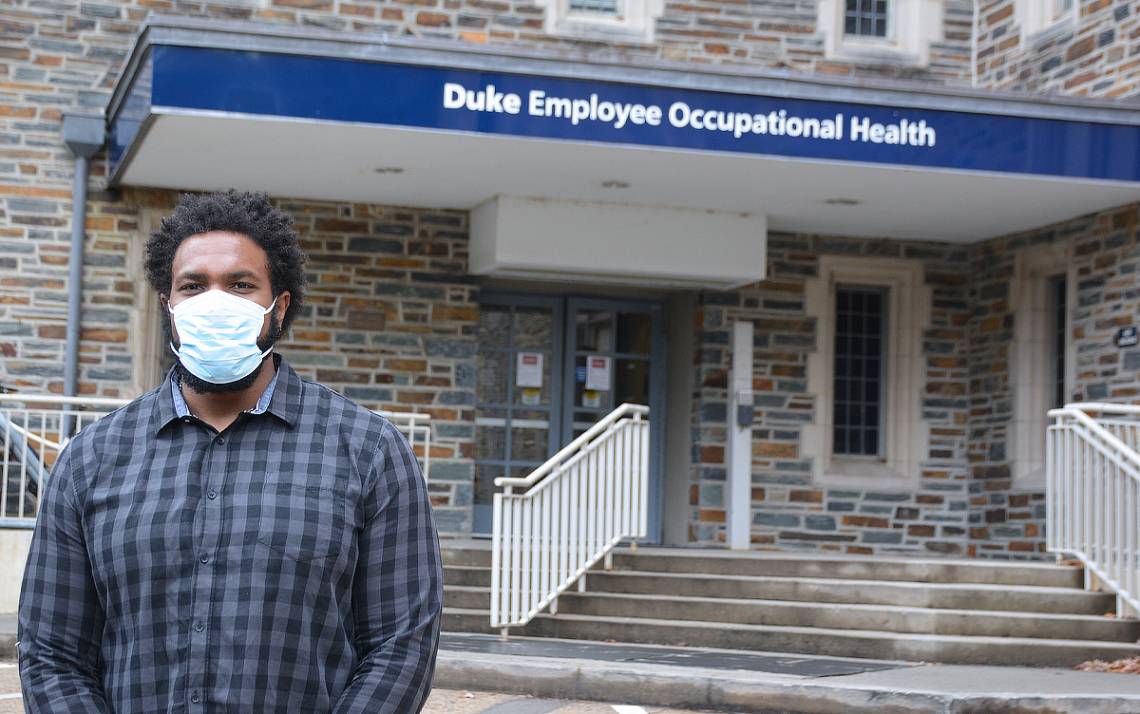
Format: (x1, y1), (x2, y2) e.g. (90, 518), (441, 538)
(333, 417), (443, 714)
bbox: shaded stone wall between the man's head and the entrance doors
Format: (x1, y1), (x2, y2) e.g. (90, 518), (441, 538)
(279, 200), (478, 533)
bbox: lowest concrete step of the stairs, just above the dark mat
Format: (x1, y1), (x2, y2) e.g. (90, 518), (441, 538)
(443, 607), (1140, 654)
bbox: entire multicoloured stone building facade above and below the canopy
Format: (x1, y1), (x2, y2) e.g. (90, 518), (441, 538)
(0, 0), (1140, 549)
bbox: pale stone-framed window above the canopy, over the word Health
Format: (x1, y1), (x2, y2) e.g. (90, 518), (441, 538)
(819, 0), (944, 66)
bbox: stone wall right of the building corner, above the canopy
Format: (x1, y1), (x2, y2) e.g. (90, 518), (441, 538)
(976, 0), (1140, 97)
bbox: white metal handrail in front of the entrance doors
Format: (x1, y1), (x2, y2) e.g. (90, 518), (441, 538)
(490, 404), (650, 636)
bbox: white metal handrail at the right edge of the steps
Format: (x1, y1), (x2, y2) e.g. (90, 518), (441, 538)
(1045, 403), (1140, 616)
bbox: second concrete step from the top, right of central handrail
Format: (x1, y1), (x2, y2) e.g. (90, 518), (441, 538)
(583, 570), (1115, 615)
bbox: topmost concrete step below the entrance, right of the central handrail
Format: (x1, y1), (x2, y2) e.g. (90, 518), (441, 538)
(611, 547), (1084, 589)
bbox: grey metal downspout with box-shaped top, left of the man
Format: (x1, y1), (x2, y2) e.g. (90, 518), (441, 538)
(63, 114), (106, 436)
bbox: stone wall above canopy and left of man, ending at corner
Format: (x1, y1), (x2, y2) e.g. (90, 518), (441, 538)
(0, 0), (972, 396)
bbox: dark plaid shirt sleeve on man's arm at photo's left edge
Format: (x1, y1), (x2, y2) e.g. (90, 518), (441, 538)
(17, 443), (111, 714)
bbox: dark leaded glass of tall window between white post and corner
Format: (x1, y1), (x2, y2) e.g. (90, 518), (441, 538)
(832, 286), (887, 456)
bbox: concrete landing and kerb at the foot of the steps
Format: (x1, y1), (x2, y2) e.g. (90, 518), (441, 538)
(435, 633), (1140, 714)
